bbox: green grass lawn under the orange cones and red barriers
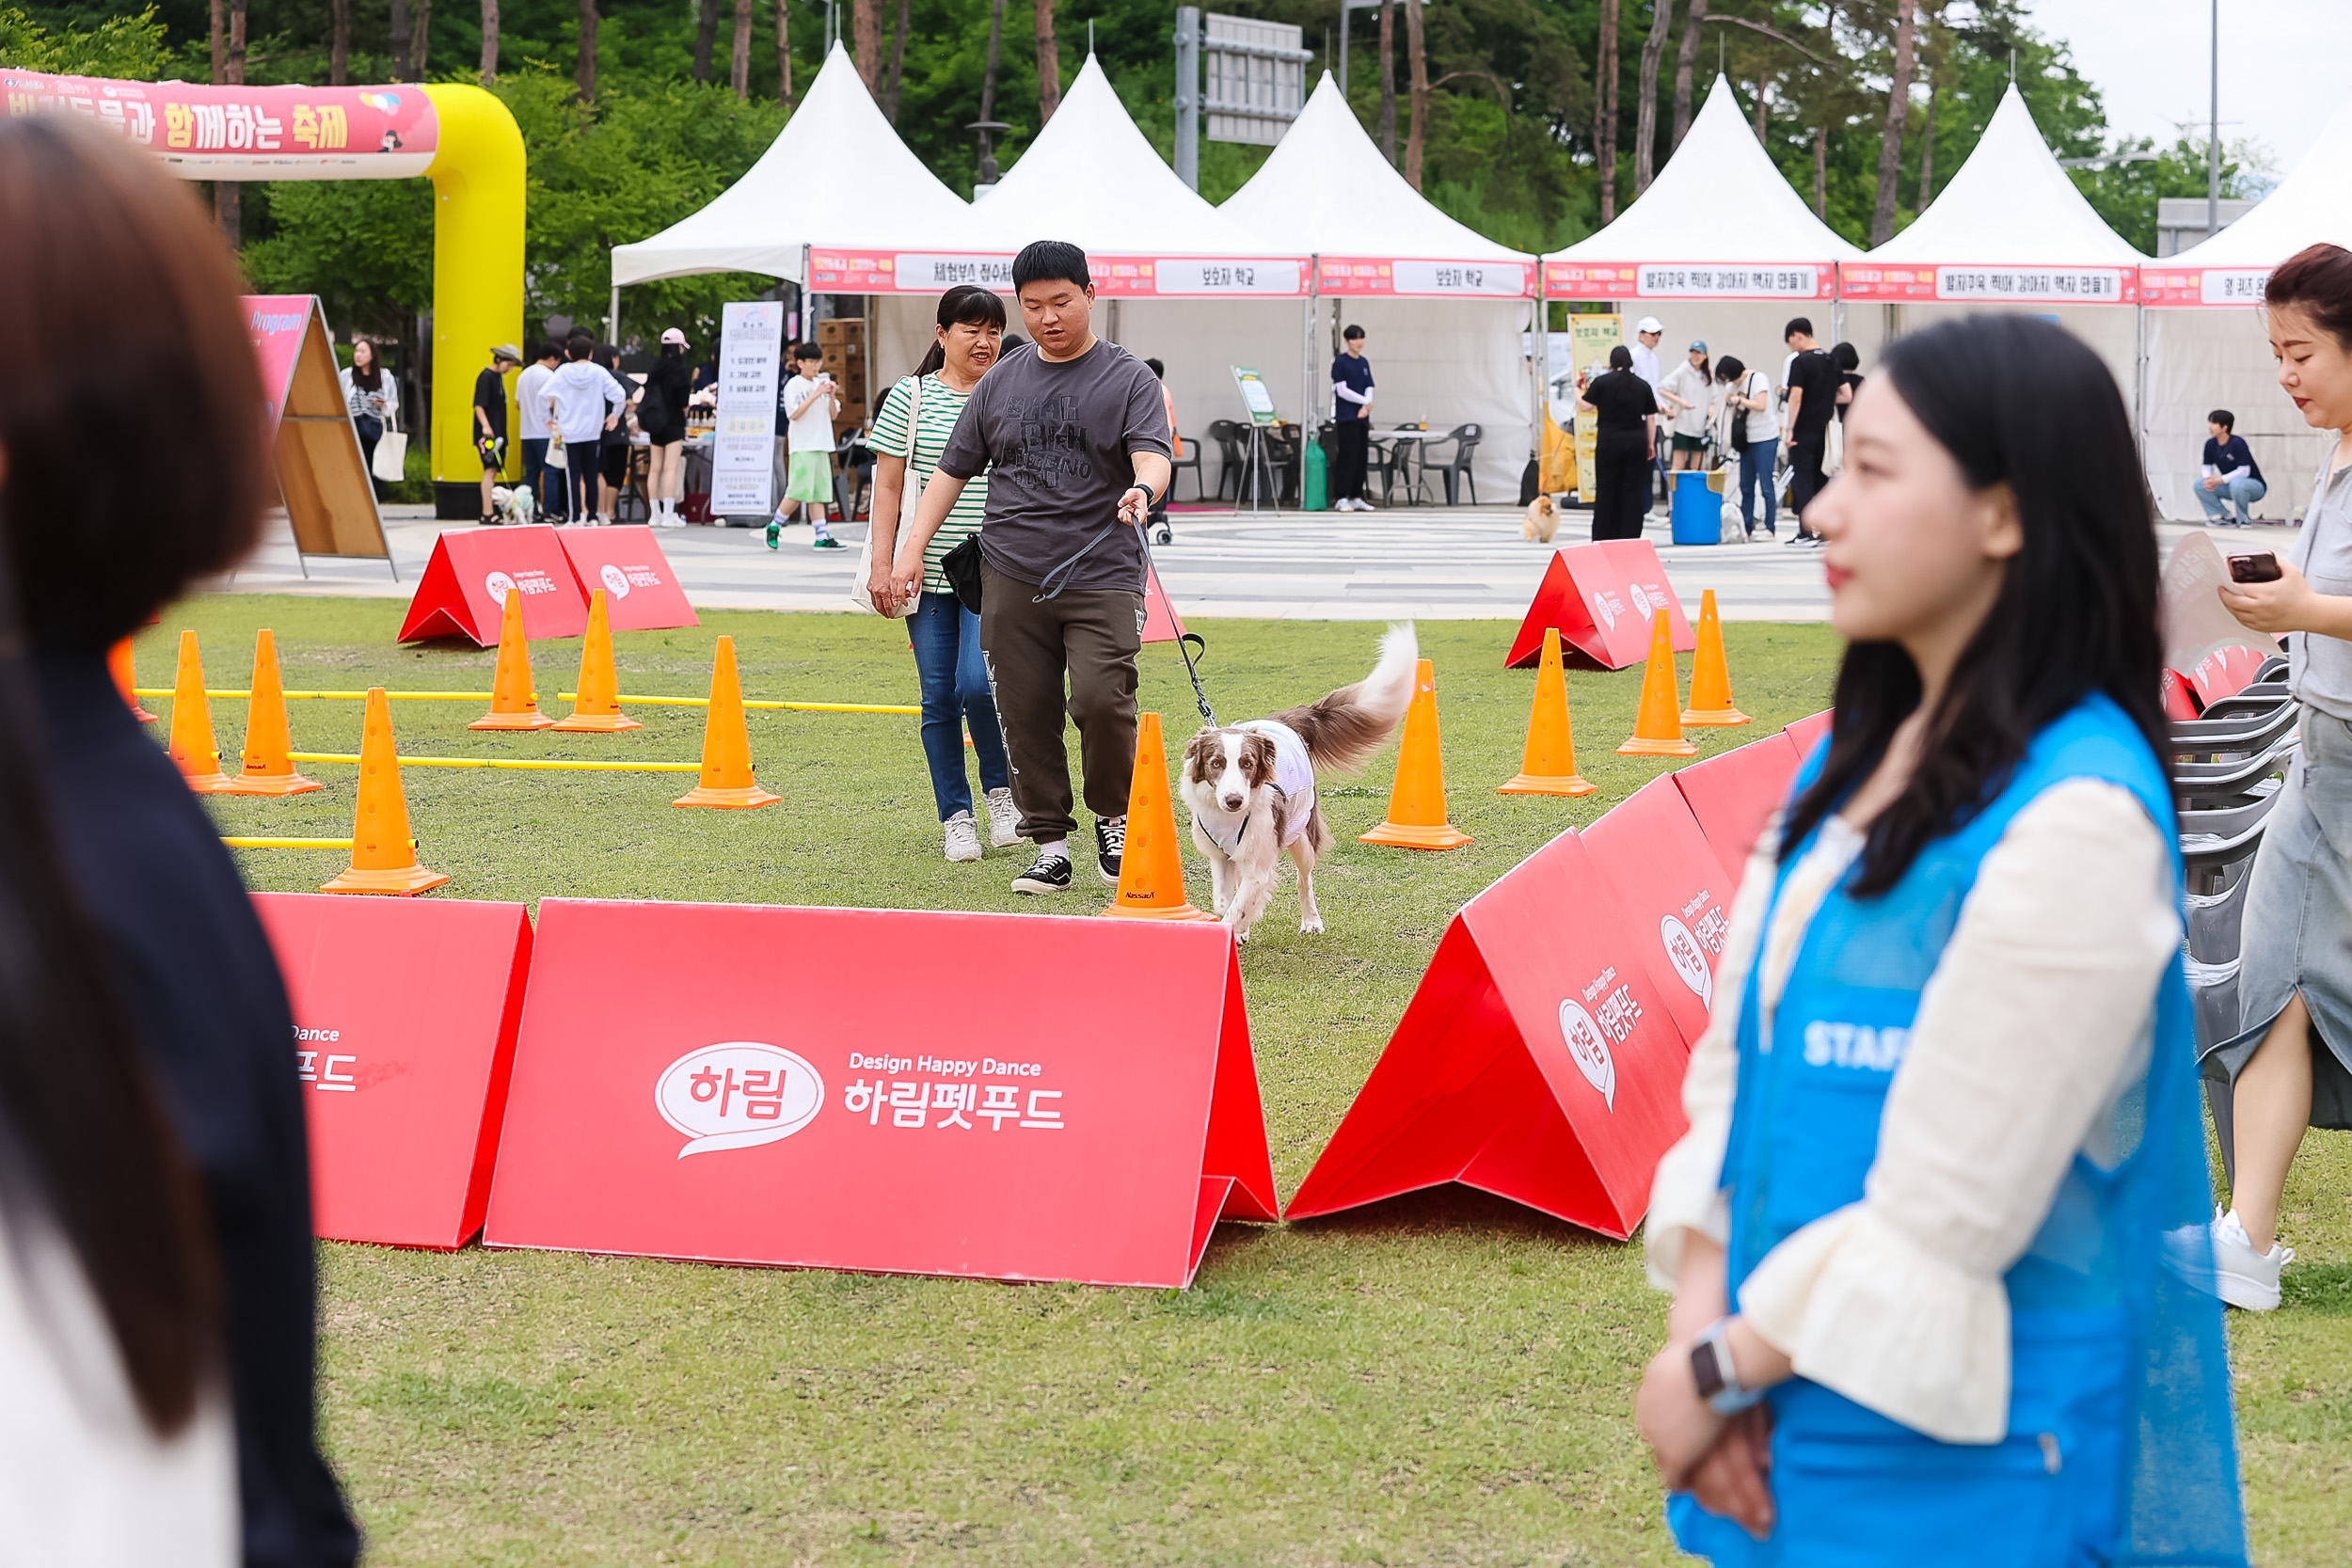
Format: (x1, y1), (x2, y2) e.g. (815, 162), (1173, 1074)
(141, 597), (2352, 1566)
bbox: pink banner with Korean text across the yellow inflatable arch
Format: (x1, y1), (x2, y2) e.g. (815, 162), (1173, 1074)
(0, 71), (440, 179)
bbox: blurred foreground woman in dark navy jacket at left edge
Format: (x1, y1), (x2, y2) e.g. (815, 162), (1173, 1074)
(0, 115), (358, 1568)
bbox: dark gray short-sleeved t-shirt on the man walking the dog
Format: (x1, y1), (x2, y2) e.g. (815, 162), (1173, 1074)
(939, 341), (1174, 593)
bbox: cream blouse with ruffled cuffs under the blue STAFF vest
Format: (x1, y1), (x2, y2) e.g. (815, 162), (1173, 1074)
(1649, 778), (2181, 1444)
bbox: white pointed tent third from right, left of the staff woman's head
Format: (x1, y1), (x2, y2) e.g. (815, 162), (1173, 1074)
(1543, 75), (1880, 413)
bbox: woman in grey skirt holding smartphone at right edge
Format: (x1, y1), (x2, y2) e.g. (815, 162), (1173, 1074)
(2211, 245), (2352, 1312)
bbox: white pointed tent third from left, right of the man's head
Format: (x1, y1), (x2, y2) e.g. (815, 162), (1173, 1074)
(1110, 72), (1536, 500)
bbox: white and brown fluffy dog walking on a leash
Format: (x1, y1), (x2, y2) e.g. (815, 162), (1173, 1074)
(1184, 626), (1421, 942)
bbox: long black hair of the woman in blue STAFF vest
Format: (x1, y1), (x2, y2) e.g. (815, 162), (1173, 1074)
(1781, 315), (2164, 895)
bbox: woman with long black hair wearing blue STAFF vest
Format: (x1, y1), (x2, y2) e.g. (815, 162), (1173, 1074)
(1637, 317), (2247, 1568)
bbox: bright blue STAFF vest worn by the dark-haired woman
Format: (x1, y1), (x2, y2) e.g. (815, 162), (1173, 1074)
(1668, 696), (2247, 1568)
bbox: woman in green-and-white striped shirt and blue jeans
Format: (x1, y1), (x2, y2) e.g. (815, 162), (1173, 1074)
(868, 284), (1021, 861)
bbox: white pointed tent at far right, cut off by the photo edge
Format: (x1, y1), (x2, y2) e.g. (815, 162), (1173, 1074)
(2140, 103), (2352, 519)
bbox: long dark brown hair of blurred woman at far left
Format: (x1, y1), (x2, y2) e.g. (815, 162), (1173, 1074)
(0, 115), (223, 1434)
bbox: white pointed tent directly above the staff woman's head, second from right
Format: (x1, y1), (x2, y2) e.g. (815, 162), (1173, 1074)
(1839, 82), (2145, 404)
